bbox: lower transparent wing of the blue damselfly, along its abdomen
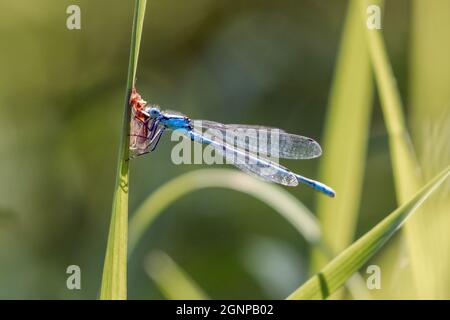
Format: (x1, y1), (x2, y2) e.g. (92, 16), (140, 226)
(191, 130), (298, 186)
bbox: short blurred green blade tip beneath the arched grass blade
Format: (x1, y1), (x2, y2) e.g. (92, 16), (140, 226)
(145, 251), (209, 300)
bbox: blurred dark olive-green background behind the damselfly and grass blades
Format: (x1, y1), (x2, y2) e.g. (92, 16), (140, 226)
(0, 0), (450, 299)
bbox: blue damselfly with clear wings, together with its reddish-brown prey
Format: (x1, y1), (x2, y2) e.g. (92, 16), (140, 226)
(130, 90), (335, 197)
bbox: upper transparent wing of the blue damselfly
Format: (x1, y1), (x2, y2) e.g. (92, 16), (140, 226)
(193, 120), (322, 159)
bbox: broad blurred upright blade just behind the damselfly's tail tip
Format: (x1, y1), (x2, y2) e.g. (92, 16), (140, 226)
(311, 0), (373, 271)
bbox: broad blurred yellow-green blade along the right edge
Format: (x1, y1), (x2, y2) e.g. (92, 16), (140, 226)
(408, 0), (450, 299)
